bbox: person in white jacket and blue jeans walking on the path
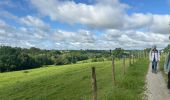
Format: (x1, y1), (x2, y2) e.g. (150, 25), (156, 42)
(149, 46), (160, 73)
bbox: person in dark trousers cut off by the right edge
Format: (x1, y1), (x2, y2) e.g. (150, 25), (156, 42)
(164, 53), (170, 89)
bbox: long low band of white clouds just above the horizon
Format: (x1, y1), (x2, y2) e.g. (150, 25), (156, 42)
(0, 19), (169, 49)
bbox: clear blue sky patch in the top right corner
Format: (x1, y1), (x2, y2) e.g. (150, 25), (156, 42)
(121, 0), (170, 14)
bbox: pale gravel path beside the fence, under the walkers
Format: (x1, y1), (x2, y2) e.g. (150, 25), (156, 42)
(145, 64), (170, 100)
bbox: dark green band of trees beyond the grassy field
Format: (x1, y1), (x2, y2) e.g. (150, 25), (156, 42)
(0, 46), (133, 72)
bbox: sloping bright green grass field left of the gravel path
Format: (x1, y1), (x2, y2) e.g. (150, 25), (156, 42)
(0, 60), (148, 100)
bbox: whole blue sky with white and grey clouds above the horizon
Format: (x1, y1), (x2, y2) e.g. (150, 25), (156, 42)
(0, 0), (170, 49)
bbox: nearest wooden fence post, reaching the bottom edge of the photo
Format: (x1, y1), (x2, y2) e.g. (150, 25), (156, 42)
(92, 67), (97, 100)
